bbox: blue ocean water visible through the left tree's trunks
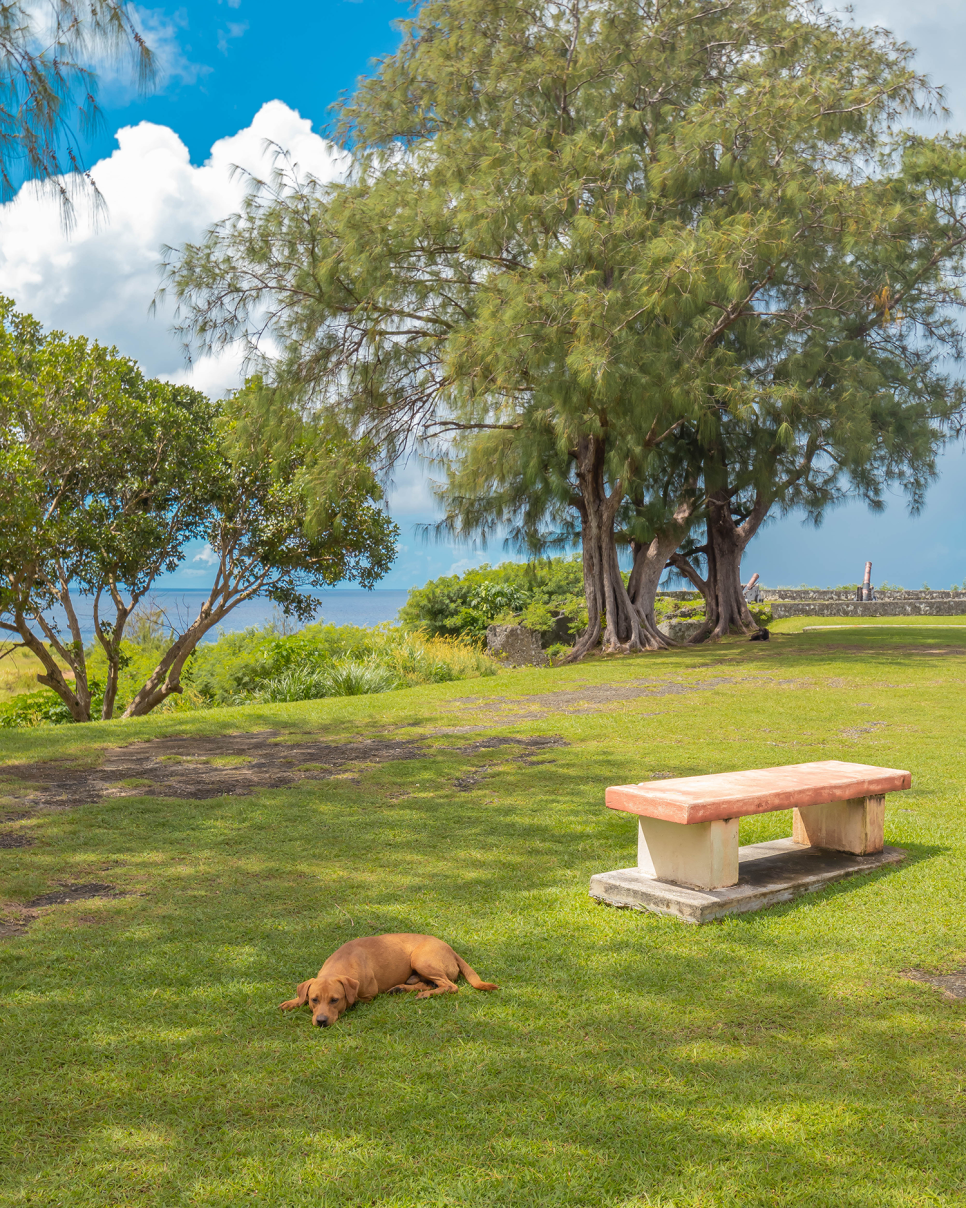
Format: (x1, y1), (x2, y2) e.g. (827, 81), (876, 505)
(30, 587), (409, 641)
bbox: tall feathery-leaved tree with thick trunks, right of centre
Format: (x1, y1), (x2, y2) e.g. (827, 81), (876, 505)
(168, 0), (965, 657)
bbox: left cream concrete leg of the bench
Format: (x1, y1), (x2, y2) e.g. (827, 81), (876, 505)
(638, 817), (738, 889)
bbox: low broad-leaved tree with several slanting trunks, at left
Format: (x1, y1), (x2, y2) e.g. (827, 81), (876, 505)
(0, 298), (396, 721)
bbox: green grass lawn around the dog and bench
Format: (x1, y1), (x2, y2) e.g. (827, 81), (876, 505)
(0, 618), (966, 1208)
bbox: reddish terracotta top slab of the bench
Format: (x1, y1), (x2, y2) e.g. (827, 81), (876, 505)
(605, 759), (912, 823)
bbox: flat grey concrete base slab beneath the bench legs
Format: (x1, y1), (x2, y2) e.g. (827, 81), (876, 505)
(590, 827), (906, 923)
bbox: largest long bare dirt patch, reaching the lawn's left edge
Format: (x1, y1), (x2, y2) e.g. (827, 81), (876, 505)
(0, 730), (566, 821)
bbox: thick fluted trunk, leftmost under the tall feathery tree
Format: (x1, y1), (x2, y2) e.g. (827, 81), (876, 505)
(564, 436), (664, 663)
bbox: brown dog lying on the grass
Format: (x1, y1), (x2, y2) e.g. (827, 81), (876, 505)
(279, 934), (500, 1028)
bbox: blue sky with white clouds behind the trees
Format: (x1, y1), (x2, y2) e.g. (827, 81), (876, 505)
(0, 0), (966, 587)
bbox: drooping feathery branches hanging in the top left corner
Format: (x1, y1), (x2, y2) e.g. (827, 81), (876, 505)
(0, 0), (155, 213)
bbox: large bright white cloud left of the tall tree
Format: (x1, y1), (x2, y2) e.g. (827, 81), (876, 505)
(0, 100), (342, 395)
